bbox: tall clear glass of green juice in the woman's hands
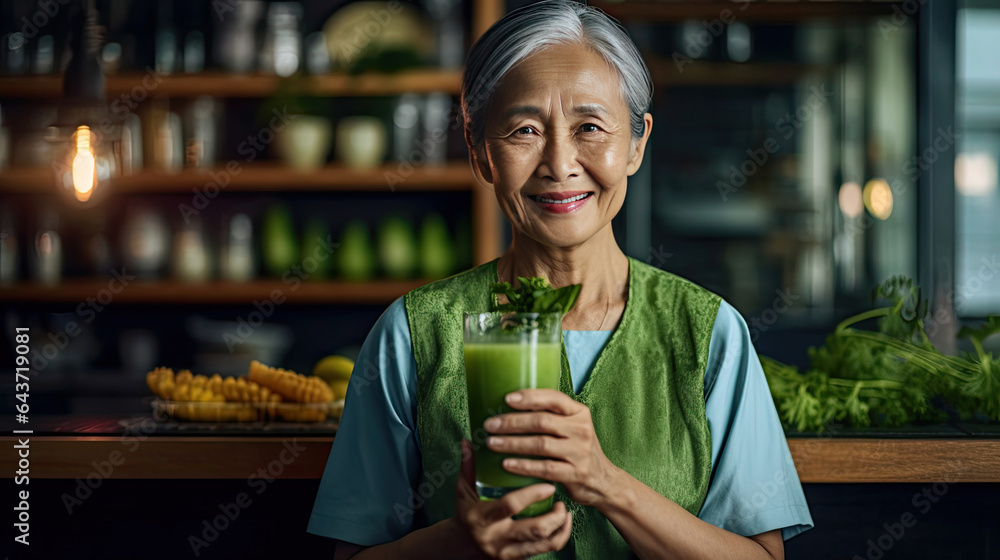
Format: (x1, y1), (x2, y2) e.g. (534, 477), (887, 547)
(464, 312), (562, 517)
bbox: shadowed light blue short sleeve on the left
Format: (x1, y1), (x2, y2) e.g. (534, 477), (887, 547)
(307, 298), (420, 546)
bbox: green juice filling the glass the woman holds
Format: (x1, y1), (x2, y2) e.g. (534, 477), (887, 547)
(465, 342), (562, 516)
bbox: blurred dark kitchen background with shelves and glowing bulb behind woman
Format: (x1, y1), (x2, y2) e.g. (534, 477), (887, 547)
(0, 0), (1000, 413)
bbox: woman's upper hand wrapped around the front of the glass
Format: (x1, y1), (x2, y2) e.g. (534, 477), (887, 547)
(484, 389), (624, 507)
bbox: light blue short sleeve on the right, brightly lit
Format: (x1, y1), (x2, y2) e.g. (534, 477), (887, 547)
(698, 302), (813, 540)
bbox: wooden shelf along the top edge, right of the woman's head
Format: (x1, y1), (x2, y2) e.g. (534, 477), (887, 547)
(591, 0), (893, 23)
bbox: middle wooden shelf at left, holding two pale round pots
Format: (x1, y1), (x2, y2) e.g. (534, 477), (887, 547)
(0, 161), (474, 194)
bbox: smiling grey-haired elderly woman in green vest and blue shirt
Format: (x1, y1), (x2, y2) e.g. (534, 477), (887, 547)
(309, 1), (812, 560)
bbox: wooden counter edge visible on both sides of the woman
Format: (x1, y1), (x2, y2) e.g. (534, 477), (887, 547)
(0, 435), (1000, 483)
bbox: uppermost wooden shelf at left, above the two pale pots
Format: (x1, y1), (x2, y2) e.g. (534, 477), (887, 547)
(0, 69), (462, 99)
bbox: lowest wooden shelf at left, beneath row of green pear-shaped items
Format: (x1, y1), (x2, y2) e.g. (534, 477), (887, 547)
(0, 280), (430, 305)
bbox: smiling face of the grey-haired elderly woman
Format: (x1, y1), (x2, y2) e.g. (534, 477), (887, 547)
(477, 41), (653, 247)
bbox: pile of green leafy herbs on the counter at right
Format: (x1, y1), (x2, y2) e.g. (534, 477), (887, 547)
(761, 276), (1000, 431)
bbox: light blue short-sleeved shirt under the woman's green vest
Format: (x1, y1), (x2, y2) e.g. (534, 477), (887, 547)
(307, 298), (813, 546)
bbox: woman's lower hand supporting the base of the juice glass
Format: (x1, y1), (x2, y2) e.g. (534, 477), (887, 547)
(455, 440), (573, 559)
